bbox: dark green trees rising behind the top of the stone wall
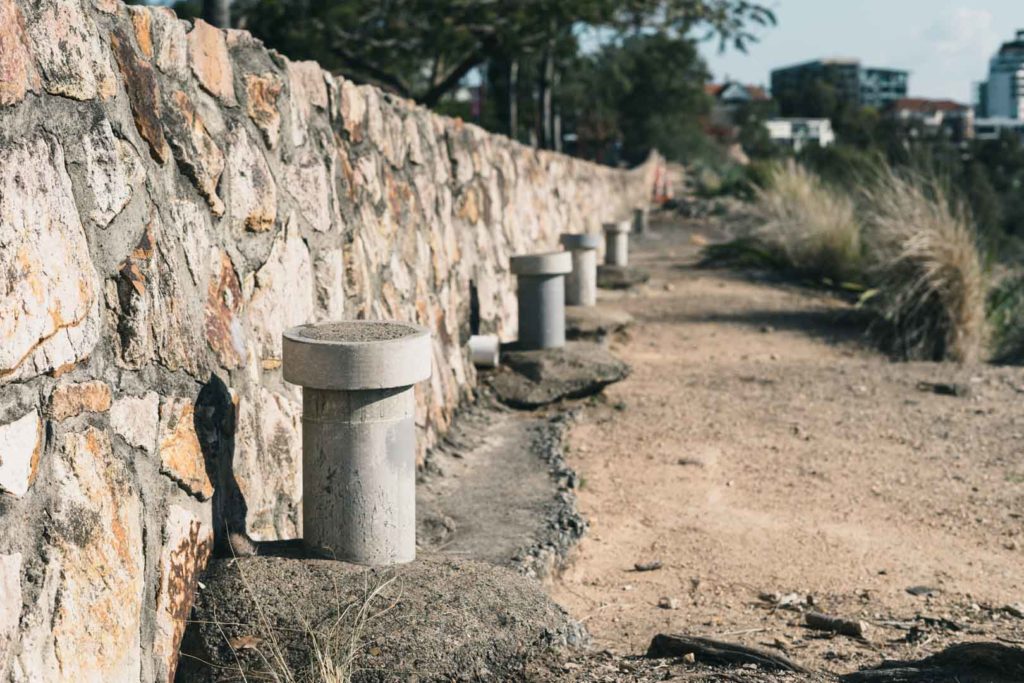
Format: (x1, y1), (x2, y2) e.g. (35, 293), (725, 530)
(220, 0), (775, 154)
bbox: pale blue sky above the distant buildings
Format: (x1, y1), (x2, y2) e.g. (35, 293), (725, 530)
(701, 0), (1024, 102)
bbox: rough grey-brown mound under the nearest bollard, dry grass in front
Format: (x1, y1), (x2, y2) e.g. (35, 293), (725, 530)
(177, 556), (585, 682)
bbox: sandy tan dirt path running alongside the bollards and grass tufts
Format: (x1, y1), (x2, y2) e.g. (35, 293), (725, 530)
(552, 211), (1024, 672)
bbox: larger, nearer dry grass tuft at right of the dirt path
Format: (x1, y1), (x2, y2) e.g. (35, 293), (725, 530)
(863, 170), (985, 362)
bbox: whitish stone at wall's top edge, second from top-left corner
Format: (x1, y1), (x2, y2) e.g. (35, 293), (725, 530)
(26, 0), (117, 99)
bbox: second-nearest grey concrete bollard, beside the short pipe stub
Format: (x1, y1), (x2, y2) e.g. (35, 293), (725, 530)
(511, 251), (572, 350)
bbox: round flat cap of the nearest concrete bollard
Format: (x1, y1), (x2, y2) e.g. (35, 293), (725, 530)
(283, 321), (433, 391)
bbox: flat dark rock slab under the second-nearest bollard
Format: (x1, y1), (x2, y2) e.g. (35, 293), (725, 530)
(489, 342), (630, 408)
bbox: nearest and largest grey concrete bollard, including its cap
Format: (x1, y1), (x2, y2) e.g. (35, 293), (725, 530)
(284, 321), (432, 565)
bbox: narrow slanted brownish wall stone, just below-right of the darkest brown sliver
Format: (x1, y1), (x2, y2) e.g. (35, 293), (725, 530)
(164, 90), (224, 216)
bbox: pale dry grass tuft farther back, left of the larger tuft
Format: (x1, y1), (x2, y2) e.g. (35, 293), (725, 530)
(752, 160), (862, 283)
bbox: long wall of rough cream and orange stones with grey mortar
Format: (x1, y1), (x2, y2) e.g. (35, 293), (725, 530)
(0, 0), (656, 682)
